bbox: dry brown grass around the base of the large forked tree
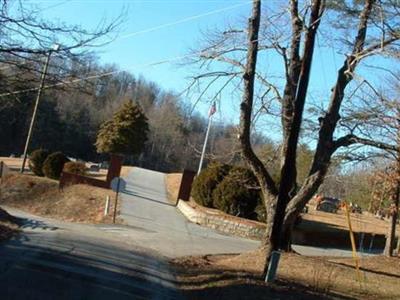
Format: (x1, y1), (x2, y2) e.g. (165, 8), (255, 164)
(172, 250), (400, 299)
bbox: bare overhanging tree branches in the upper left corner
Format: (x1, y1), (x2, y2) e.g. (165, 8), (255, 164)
(0, 0), (122, 94)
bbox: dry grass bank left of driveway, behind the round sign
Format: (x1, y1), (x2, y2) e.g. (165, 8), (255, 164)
(0, 174), (120, 223)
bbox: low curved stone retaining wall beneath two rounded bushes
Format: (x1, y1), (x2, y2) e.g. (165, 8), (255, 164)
(177, 200), (265, 240)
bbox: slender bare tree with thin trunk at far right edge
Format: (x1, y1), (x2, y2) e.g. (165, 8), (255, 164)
(344, 71), (400, 256)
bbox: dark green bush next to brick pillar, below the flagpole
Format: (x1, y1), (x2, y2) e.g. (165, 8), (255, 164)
(192, 163), (232, 207)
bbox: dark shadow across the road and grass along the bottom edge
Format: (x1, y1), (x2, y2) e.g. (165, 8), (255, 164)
(0, 227), (360, 300)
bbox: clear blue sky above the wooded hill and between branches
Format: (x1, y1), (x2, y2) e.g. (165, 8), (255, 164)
(24, 0), (382, 131)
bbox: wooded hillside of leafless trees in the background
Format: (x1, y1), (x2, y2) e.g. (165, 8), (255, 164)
(0, 57), (266, 171)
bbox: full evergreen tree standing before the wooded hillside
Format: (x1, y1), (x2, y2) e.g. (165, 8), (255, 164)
(95, 101), (149, 155)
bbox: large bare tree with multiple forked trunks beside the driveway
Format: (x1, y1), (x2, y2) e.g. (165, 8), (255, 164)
(188, 0), (400, 272)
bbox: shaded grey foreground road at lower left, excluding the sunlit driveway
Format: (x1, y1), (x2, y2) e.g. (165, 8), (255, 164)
(0, 208), (181, 300)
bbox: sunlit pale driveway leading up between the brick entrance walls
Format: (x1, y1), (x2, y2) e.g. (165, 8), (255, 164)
(121, 168), (259, 257)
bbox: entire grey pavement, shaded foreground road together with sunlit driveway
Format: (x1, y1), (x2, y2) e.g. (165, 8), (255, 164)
(0, 168), (378, 300)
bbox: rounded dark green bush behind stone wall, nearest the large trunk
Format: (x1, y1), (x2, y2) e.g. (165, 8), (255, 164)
(213, 167), (261, 220)
